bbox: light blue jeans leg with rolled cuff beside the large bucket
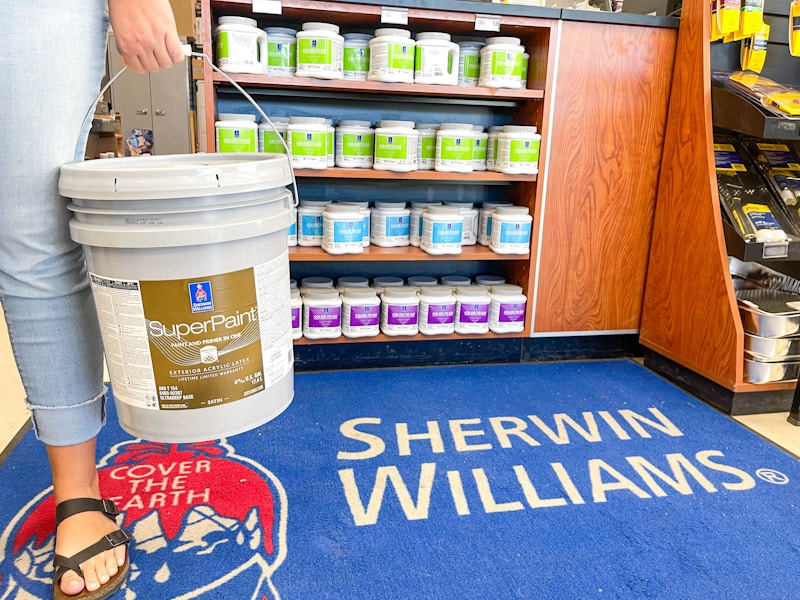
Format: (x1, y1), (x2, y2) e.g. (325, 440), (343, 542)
(0, 0), (108, 446)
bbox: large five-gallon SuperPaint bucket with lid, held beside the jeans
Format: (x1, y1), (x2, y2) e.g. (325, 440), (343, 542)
(59, 154), (294, 443)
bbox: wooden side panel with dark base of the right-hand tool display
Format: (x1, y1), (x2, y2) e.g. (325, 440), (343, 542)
(640, 0), (795, 414)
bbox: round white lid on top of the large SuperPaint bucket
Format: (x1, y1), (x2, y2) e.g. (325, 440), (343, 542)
(58, 153), (292, 200)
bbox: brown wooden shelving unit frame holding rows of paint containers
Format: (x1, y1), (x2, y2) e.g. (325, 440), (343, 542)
(201, 0), (557, 345)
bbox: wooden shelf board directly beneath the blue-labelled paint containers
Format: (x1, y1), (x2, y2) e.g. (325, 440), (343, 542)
(289, 244), (530, 262)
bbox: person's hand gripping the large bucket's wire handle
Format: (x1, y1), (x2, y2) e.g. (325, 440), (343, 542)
(108, 0), (185, 73)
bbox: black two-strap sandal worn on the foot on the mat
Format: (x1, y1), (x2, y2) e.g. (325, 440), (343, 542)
(53, 498), (133, 600)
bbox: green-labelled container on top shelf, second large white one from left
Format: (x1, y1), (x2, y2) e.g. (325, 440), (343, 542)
(296, 22), (344, 79)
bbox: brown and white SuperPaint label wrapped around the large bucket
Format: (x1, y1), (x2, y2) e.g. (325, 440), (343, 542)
(91, 253), (294, 410)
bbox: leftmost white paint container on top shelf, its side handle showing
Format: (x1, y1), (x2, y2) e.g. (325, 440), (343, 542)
(214, 16), (269, 75)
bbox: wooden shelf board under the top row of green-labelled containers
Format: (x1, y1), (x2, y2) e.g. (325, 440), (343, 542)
(213, 73), (544, 101)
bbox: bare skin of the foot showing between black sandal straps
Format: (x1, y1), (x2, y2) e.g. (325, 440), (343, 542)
(56, 511), (126, 596)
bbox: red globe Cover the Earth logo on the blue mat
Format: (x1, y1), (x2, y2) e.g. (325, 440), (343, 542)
(0, 440), (288, 600)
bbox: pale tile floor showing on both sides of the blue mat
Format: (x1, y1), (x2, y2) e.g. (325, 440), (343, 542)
(0, 310), (800, 459)
